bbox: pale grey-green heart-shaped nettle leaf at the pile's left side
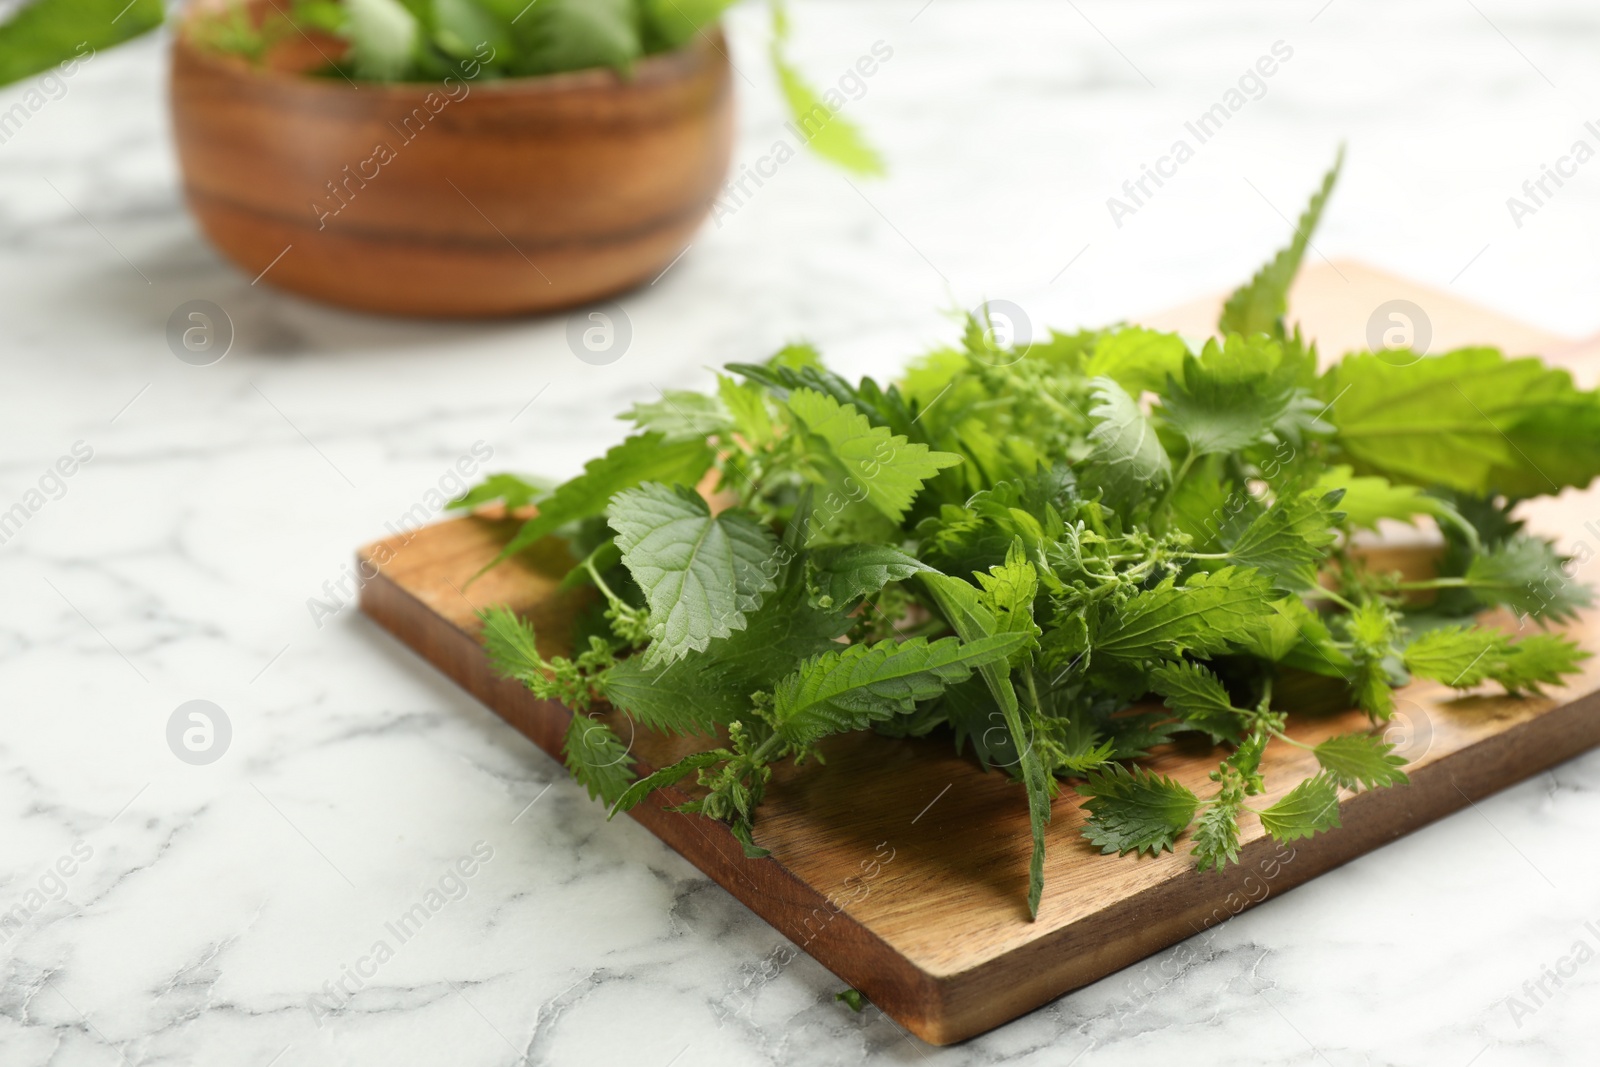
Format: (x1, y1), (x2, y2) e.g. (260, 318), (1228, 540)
(608, 483), (778, 667)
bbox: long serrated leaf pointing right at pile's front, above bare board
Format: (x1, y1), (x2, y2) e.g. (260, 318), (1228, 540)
(771, 633), (1026, 745)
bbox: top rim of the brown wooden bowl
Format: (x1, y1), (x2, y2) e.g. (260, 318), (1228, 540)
(173, 3), (728, 101)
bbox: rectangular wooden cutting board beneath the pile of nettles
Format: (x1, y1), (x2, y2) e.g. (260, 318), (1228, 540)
(358, 264), (1600, 1045)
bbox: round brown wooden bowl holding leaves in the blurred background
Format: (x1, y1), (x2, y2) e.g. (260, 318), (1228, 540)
(171, 8), (733, 317)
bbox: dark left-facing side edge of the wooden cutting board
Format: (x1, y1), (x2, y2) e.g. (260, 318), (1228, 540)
(357, 559), (966, 1045)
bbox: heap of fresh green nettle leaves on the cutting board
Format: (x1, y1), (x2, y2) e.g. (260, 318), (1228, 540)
(458, 154), (1600, 913)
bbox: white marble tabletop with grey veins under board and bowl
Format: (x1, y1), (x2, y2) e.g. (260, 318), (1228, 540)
(0, 0), (1600, 1067)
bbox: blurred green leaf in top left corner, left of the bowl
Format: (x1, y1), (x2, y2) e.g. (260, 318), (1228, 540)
(0, 0), (163, 85)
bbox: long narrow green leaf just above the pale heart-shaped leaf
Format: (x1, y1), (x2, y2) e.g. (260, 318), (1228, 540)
(478, 434), (717, 574)
